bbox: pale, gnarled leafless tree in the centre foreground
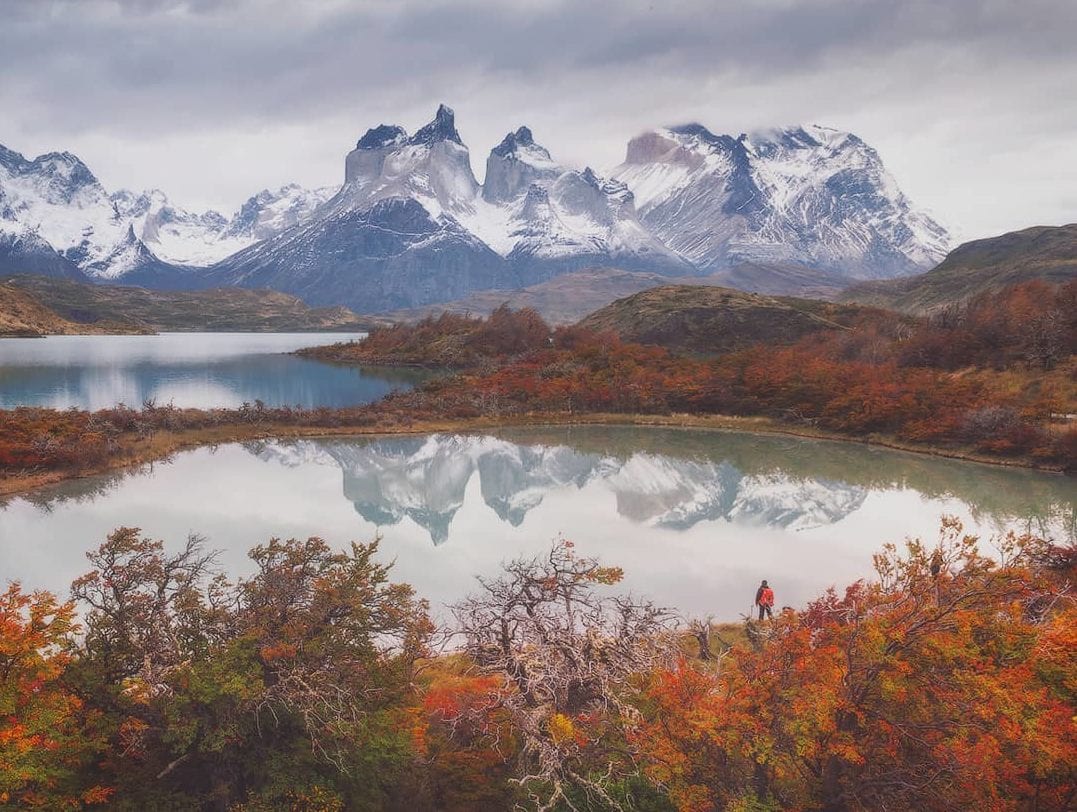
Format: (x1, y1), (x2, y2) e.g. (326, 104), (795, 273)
(453, 540), (679, 810)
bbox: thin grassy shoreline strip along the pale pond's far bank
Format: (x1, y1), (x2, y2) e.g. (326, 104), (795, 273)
(0, 412), (1067, 496)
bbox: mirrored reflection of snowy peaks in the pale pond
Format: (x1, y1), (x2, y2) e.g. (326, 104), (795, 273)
(254, 434), (867, 544)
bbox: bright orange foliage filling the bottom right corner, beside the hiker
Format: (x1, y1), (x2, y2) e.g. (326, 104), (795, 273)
(639, 521), (1077, 810)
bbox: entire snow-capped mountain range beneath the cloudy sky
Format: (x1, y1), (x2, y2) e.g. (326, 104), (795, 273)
(0, 104), (948, 305)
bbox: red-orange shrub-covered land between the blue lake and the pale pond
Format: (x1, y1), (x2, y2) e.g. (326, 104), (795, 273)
(0, 282), (1077, 484)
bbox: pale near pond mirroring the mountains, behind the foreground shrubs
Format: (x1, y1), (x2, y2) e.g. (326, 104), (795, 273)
(0, 426), (1077, 619)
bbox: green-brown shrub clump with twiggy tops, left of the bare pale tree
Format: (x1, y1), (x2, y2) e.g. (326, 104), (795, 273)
(67, 528), (432, 809)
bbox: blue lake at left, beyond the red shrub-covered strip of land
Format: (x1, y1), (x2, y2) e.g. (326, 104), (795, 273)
(0, 333), (424, 409)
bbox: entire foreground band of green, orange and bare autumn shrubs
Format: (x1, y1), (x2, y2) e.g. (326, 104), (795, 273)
(0, 518), (1077, 812)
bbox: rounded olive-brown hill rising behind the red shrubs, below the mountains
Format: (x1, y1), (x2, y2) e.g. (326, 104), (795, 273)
(579, 285), (863, 353)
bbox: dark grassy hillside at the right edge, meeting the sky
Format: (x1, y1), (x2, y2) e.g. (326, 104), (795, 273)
(839, 223), (1077, 314)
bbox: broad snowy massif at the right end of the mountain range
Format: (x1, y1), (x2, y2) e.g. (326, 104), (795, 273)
(613, 124), (949, 278)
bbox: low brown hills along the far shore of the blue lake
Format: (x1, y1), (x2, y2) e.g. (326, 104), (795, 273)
(9, 276), (376, 332)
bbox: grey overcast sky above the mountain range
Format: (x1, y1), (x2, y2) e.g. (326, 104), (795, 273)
(0, 0), (1077, 239)
